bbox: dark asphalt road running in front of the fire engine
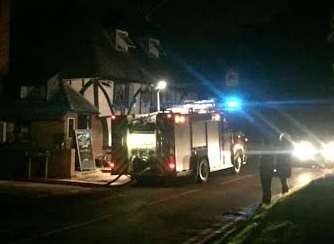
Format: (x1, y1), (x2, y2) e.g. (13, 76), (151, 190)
(0, 159), (328, 244)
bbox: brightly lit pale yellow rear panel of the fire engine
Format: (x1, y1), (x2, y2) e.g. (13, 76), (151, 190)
(127, 133), (156, 150)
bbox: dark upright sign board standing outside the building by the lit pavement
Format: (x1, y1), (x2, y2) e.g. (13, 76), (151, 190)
(75, 129), (96, 170)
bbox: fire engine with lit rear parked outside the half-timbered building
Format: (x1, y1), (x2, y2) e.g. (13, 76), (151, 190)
(127, 101), (247, 182)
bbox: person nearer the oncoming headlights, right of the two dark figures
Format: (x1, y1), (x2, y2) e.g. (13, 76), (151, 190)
(275, 133), (292, 194)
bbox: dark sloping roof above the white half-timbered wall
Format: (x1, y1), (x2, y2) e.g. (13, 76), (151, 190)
(62, 26), (176, 83)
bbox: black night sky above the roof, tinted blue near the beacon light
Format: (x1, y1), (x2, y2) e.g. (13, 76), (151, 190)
(11, 0), (334, 97)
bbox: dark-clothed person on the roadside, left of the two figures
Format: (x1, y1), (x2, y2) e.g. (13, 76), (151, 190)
(260, 139), (274, 204)
